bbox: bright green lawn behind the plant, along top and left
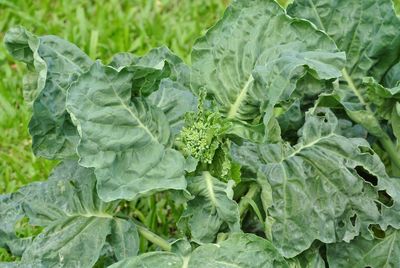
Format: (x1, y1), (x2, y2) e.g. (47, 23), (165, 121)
(0, 0), (229, 193)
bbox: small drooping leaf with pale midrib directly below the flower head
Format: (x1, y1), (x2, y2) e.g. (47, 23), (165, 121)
(179, 172), (240, 243)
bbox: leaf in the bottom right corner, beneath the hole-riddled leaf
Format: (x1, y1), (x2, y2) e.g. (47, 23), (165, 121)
(327, 229), (400, 268)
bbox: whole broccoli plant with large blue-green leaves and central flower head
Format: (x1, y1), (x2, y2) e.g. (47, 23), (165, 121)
(0, 0), (400, 268)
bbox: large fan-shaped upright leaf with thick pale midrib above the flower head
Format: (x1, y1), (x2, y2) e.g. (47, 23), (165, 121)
(191, 0), (344, 140)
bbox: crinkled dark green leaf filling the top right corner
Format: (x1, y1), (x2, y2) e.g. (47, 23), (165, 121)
(288, 0), (400, 85)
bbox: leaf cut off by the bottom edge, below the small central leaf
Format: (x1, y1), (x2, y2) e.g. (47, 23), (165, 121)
(110, 234), (288, 268)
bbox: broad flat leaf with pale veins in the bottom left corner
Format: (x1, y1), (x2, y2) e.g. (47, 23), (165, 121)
(0, 161), (139, 267)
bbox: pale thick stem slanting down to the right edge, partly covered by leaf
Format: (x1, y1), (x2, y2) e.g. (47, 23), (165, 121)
(342, 69), (400, 171)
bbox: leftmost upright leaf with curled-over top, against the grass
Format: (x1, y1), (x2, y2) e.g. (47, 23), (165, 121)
(4, 28), (92, 159)
